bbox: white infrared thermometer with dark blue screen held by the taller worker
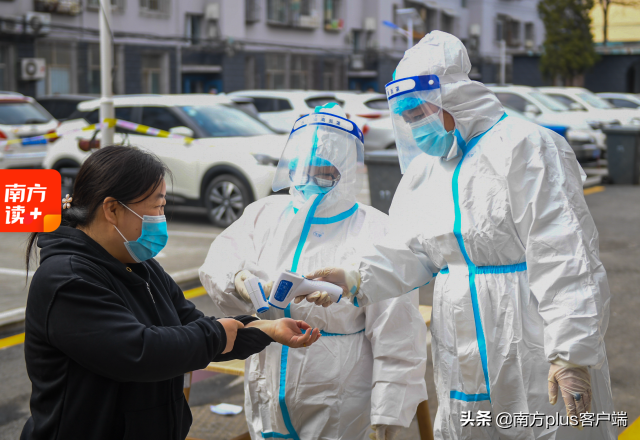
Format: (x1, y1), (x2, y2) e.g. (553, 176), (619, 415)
(269, 270), (342, 309)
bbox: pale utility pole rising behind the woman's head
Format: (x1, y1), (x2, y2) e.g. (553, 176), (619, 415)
(100, 0), (115, 146)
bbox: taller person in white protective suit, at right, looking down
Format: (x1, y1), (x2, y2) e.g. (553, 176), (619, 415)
(307, 31), (616, 440)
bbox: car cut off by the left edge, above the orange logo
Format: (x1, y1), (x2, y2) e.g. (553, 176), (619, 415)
(0, 93), (59, 168)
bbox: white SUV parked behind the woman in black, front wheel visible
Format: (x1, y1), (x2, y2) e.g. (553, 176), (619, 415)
(44, 94), (286, 227)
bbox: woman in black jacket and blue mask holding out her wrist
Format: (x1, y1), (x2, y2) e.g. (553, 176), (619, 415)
(21, 147), (319, 440)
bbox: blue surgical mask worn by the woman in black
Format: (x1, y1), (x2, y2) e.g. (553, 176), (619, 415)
(113, 202), (169, 263)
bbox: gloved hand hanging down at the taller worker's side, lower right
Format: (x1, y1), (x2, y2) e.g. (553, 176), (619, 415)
(548, 361), (591, 430)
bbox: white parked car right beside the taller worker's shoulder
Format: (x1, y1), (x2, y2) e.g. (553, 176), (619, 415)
(489, 86), (607, 162)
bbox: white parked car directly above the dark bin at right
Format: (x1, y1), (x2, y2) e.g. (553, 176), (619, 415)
(538, 87), (640, 125)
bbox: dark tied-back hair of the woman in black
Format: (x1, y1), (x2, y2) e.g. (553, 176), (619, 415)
(25, 146), (171, 277)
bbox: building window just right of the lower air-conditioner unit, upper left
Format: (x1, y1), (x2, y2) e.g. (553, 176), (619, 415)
(36, 43), (74, 96)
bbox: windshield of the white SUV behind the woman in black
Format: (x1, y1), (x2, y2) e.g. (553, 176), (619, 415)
(181, 105), (275, 137)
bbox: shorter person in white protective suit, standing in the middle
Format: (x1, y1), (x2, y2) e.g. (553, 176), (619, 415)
(200, 104), (427, 440)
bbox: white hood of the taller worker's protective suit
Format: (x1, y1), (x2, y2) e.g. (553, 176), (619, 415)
(394, 31), (504, 141)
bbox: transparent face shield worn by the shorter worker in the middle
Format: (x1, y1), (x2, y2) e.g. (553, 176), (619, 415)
(272, 113), (364, 196)
